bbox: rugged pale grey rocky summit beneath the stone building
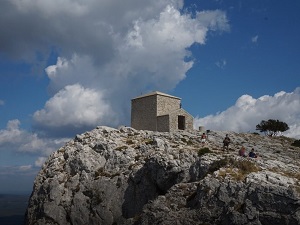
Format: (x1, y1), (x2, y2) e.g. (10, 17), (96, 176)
(26, 127), (300, 225)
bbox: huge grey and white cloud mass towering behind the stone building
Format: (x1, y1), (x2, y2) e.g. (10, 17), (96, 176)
(0, 0), (229, 137)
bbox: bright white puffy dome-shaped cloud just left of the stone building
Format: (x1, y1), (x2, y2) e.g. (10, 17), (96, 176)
(33, 84), (115, 135)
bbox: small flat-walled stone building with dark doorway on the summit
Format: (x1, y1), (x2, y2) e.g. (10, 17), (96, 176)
(131, 91), (194, 132)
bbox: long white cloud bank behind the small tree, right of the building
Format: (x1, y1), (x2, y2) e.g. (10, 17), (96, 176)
(195, 87), (300, 139)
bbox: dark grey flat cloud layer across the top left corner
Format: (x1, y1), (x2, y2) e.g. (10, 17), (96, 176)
(0, 0), (183, 64)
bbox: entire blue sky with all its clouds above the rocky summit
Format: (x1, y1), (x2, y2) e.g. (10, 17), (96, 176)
(0, 0), (300, 193)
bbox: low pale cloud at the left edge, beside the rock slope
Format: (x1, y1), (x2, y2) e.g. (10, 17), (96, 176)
(0, 120), (67, 156)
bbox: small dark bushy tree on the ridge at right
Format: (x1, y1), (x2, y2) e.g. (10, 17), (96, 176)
(256, 119), (290, 136)
